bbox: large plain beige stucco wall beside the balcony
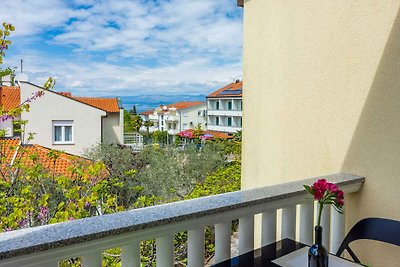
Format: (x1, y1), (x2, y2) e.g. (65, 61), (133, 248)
(242, 0), (400, 266)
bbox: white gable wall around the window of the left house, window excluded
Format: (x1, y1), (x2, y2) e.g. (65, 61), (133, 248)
(21, 82), (106, 155)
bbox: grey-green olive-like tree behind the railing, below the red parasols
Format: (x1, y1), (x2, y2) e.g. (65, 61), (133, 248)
(138, 144), (224, 200)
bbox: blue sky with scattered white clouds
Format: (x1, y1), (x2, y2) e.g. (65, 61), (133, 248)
(0, 0), (242, 96)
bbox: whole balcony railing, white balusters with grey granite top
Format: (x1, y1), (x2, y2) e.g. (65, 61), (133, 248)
(0, 174), (364, 267)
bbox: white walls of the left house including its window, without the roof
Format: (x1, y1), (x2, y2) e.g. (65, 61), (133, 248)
(20, 82), (123, 155)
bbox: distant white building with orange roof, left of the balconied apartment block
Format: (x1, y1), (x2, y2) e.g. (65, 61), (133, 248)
(140, 102), (206, 135)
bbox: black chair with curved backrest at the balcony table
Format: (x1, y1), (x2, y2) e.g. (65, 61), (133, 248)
(336, 218), (400, 263)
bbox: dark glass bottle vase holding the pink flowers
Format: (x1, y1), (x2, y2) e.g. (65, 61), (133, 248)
(308, 226), (329, 267)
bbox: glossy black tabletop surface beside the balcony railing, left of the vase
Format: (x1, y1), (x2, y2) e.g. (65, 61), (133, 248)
(214, 238), (307, 267)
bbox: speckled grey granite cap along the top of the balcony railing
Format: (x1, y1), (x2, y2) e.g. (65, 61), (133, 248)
(0, 173), (364, 259)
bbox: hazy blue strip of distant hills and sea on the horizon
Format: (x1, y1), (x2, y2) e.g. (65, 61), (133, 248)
(120, 95), (206, 112)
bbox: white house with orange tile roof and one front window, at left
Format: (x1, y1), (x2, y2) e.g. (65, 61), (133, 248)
(0, 82), (123, 155)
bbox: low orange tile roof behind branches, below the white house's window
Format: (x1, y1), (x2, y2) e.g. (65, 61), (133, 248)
(0, 139), (104, 177)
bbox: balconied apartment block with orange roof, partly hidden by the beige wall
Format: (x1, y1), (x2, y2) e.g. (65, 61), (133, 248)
(207, 81), (243, 133)
